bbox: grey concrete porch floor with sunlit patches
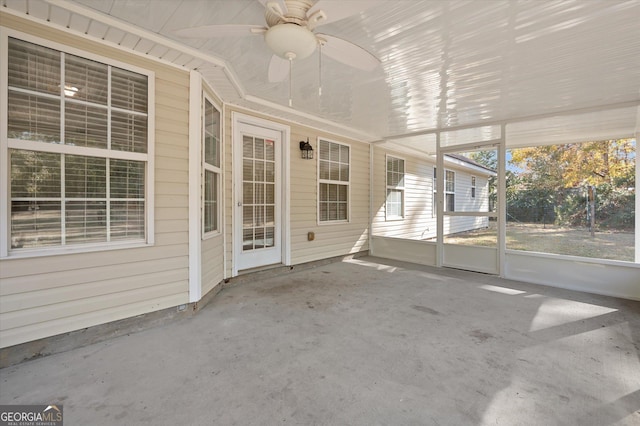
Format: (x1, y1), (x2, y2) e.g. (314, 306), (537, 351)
(0, 257), (640, 426)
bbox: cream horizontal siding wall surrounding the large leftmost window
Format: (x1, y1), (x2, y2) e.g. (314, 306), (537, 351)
(0, 14), (189, 347)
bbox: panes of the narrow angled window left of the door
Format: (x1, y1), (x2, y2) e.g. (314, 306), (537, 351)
(202, 98), (221, 233)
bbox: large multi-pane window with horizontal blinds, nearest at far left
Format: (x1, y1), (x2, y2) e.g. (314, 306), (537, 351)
(0, 37), (150, 250)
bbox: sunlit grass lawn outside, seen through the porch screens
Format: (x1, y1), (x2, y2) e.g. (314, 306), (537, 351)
(445, 222), (635, 262)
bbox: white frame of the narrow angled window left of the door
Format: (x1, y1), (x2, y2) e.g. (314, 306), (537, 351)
(200, 92), (224, 240)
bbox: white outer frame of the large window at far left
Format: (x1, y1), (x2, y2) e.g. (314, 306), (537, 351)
(0, 27), (155, 258)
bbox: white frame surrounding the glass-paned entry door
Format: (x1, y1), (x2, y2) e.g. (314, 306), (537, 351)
(230, 111), (291, 277)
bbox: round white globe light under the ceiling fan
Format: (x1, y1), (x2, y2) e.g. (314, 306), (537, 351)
(264, 24), (318, 60)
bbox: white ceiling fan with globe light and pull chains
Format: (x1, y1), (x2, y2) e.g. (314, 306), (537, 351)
(175, 0), (380, 93)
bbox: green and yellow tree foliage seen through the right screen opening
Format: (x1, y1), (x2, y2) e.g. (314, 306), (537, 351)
(507, 139), (636, 230)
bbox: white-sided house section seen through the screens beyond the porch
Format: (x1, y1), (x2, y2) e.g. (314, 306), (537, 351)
(372, 150), (496, 240)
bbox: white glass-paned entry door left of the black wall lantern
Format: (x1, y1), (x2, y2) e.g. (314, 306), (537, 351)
(233, 123), (282, 271)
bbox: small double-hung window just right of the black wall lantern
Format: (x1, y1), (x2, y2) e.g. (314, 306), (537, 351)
(318, 139), (350, 222)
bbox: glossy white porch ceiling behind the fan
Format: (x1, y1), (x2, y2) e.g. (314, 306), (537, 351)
(2, 0), (640, 141)
